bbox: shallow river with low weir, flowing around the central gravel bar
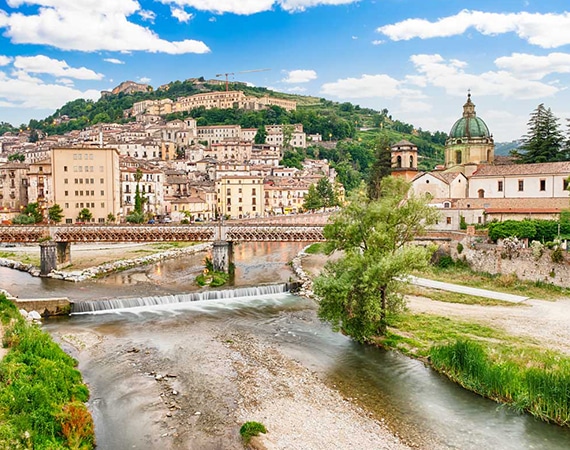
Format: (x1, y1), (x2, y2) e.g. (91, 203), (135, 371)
(0, 244), (570, 450)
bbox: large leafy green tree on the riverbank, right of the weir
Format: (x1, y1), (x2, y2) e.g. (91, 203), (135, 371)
(314, 177), (438, 342)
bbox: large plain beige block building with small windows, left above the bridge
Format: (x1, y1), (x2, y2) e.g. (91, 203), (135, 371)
(51, 147), (120, 223)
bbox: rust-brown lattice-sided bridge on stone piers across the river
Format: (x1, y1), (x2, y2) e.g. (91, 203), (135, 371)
(0, 220), (328, 275)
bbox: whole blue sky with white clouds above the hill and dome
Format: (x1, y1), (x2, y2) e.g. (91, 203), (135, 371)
(0, 0), (570, 142)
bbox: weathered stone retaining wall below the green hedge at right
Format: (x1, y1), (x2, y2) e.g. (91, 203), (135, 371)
(450, 237), (570, 287)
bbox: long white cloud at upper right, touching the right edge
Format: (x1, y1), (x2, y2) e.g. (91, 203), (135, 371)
(377, 10), (570, 48)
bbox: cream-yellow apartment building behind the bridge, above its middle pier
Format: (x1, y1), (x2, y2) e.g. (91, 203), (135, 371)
(216, 175), (264, 219)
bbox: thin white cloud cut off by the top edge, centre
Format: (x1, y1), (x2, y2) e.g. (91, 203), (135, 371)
(160, 0), (360, 15)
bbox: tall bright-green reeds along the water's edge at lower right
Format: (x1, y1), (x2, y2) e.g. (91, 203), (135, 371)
(430, 339), (570, 426)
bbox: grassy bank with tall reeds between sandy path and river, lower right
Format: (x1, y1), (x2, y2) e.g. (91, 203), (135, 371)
(377, 313), (570, 426)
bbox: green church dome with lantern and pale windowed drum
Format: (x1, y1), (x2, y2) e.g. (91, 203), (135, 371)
(445, 93), (495, 176)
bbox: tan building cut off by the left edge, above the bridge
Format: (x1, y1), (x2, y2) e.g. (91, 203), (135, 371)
(0, 162), (30, 213)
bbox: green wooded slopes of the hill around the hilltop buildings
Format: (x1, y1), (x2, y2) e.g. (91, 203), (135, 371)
(4, 78), (447, 189)
